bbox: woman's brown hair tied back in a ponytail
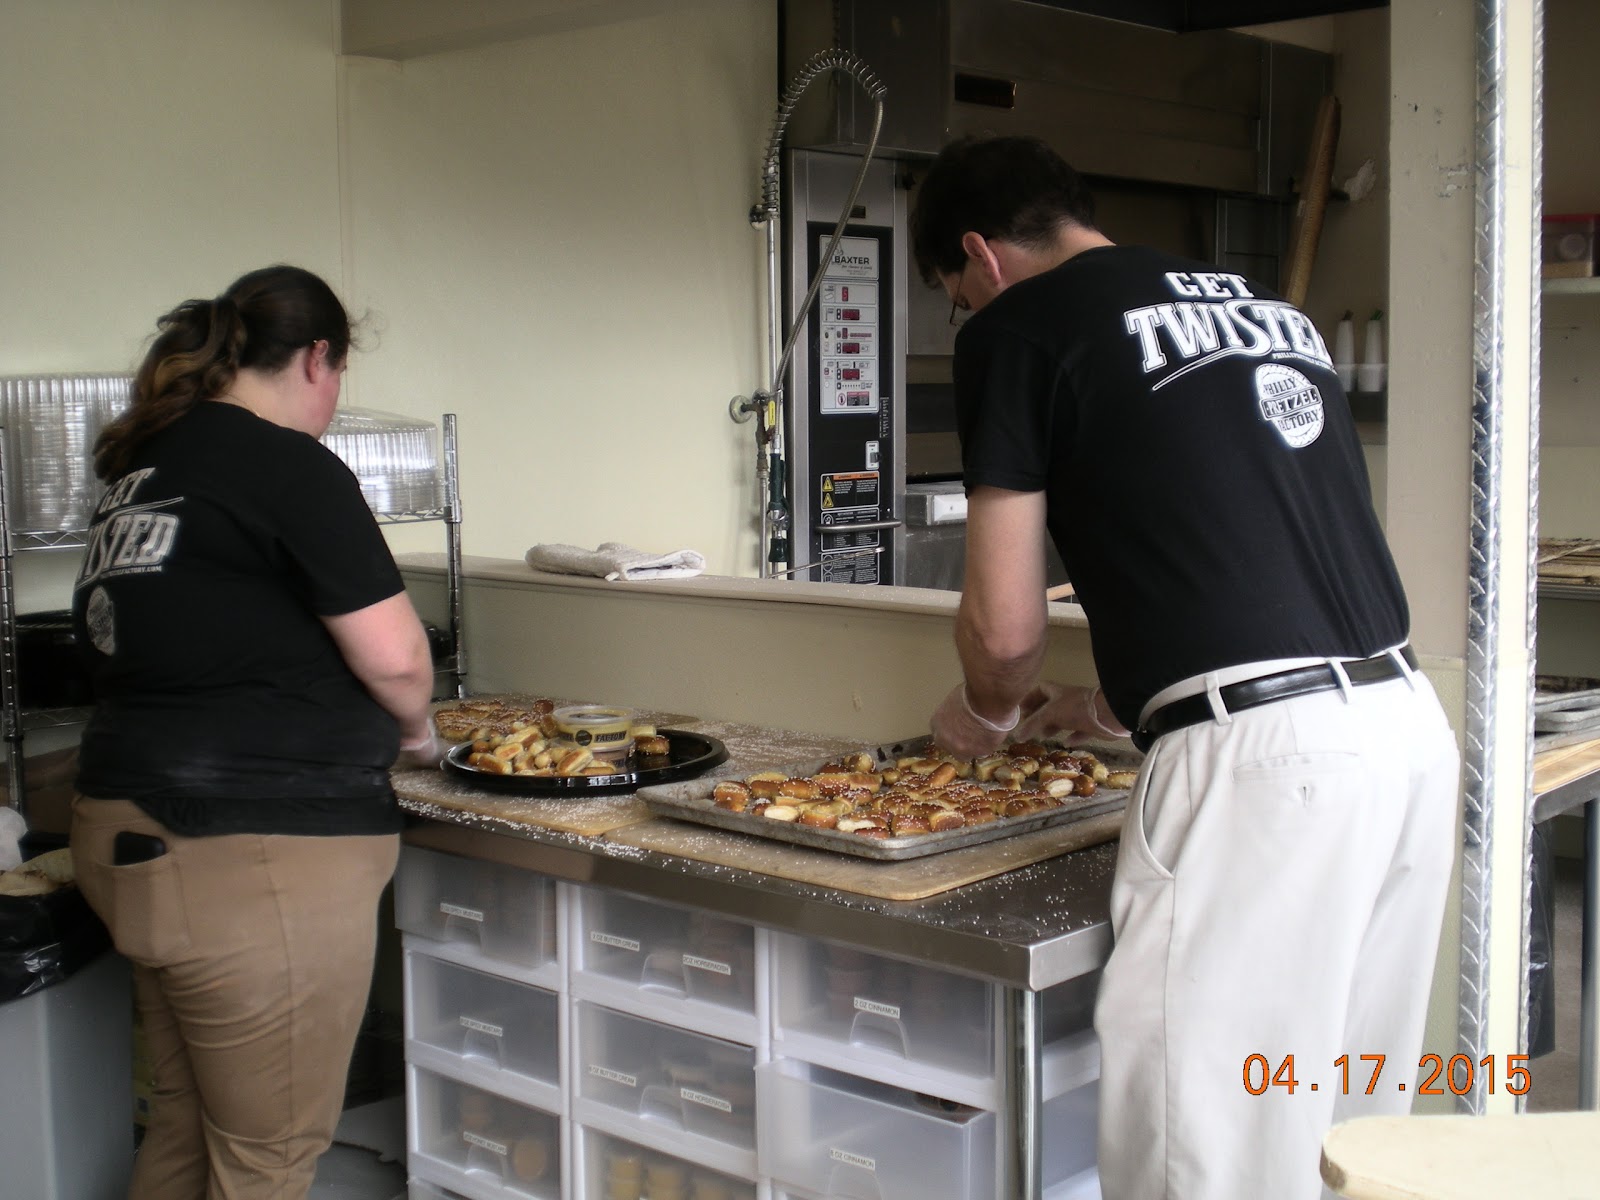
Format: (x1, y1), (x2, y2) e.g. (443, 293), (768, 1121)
(94, 266), (350, 482)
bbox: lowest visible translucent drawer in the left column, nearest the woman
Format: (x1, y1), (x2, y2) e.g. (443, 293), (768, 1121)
(410, 1066), (562, 1200)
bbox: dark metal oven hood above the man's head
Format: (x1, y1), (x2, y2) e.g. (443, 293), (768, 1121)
(784, 0), (1331, 198)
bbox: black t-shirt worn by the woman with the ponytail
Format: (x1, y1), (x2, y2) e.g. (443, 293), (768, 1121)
(72, 402), (402, 835)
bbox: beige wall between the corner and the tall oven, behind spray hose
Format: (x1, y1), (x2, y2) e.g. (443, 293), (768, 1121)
(344, 0), (776, 574)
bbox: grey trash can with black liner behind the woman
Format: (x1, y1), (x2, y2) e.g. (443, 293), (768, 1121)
(0, 886), (133, 1200)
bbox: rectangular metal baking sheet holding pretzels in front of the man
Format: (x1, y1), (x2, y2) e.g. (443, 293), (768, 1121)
(638, 736), (1141, 862)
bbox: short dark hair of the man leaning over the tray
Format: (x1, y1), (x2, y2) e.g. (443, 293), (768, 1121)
(910, 138), (1094, 285)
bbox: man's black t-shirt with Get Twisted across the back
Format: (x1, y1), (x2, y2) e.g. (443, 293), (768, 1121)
(955, 246), (1410, 728)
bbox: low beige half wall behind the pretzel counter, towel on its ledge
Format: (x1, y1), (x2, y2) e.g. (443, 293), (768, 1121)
(405, 555), (1094, 744)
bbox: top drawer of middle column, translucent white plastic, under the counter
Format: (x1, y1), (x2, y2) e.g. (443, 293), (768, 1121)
(574, 888), (755, 1014)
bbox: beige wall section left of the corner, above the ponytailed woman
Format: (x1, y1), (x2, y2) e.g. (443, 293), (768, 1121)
(0, 0), (342, 610)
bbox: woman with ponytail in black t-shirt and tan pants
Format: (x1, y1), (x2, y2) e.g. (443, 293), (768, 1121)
(72, 266), (442, 1200)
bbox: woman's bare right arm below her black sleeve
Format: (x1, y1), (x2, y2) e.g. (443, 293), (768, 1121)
(322, 592), (434, 747)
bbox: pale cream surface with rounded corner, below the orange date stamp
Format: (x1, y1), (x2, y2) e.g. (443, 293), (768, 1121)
(1322, 1112), (1600, 1200)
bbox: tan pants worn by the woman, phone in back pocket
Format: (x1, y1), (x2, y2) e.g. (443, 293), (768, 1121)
(72, 797), (400, 1200)
